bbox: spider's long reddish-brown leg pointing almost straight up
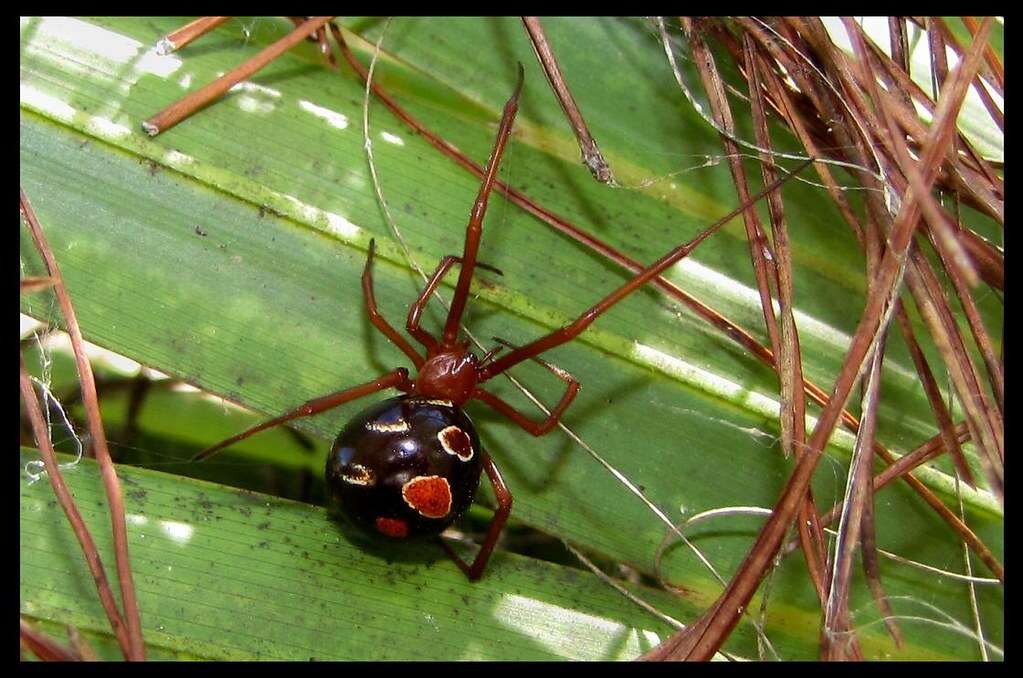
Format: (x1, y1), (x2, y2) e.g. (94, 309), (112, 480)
(443, 63), (525, 346)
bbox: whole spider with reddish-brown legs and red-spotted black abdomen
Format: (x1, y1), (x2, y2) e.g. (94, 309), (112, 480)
(194, 64), (810, 581)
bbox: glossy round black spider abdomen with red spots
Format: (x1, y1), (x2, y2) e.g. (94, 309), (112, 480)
(326, 396), (483, 539)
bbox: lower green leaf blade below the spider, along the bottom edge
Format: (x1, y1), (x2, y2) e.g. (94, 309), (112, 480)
(20, 450), (687, 660)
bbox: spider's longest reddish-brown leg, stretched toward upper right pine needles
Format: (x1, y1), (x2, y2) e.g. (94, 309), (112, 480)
(480, 160), (813, 382)
